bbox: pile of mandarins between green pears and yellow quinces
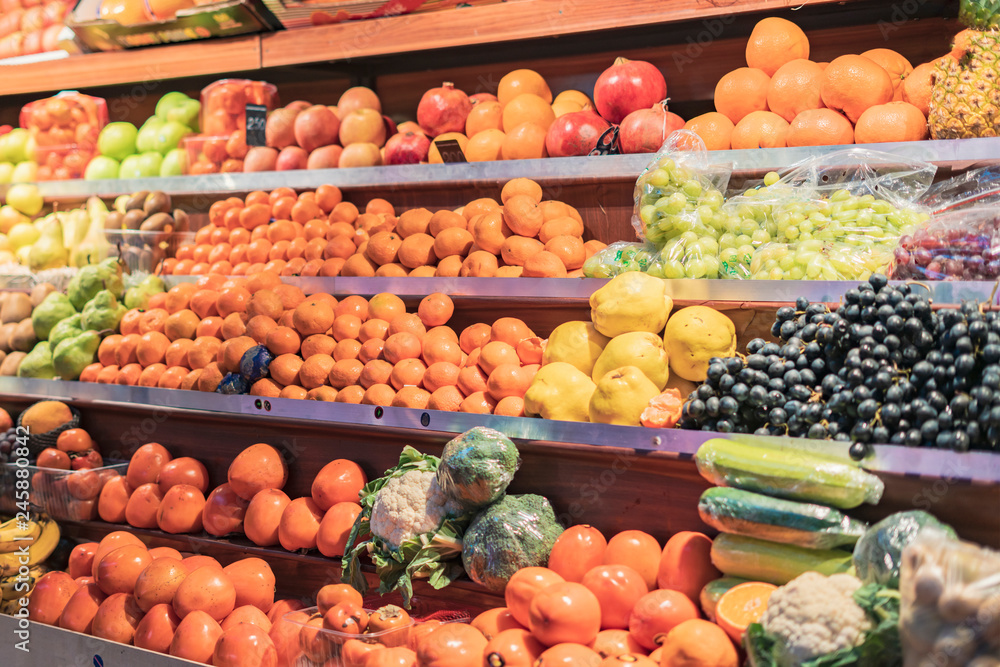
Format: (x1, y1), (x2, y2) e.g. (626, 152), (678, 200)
(80, 272), (542, 416)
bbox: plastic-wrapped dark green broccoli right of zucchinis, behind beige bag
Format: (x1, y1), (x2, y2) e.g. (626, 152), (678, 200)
(854, 510), (955, 587)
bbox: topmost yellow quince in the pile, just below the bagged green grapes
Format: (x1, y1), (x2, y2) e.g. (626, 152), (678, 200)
(590, 271), (674, 337)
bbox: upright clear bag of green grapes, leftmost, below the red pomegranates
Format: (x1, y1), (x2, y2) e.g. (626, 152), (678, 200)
(632, 130), (732, 248)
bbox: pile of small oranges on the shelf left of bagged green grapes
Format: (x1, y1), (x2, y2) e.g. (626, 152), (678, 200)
(161, 177), (605, 278)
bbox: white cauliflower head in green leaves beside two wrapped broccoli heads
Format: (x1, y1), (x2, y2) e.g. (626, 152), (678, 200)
(371, 470), (454, 547)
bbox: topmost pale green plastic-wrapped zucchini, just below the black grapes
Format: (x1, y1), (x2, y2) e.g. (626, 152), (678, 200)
(694, 438), (885, 509)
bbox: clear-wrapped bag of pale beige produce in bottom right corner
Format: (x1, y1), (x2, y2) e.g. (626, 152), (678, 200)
(899, 529), (1000, 667)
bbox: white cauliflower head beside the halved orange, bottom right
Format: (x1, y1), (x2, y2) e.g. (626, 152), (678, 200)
(761, 572), (872, 667)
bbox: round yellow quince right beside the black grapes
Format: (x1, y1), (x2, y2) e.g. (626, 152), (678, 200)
(663, 306), (736, 382)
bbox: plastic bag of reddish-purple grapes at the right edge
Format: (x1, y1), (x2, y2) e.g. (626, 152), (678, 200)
(889, 205), (1000, 281)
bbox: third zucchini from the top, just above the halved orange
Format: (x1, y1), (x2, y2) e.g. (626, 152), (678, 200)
(712, 533), (852, 586)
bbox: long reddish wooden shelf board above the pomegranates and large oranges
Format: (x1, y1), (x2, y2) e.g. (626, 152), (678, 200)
(261, 0), (876, 68)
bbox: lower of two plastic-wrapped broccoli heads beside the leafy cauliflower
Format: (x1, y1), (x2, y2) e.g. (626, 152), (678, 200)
(462, 494), (563, 593)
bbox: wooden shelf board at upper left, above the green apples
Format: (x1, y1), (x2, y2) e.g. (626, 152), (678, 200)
(0, 35), (261, 97)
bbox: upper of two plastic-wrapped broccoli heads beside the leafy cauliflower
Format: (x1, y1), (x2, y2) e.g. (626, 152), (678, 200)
(437, 426), (521, 511)
